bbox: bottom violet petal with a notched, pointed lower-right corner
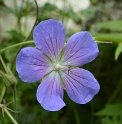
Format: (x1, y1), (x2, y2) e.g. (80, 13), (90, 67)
(36, 71), (65, 111)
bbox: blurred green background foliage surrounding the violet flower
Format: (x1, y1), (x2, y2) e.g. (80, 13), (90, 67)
(0, 0), (122, 124)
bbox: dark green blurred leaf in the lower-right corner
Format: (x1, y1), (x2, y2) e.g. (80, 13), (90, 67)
(95, 103), (122, 116)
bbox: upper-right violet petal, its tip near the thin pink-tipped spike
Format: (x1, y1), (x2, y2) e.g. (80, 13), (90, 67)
(64, 31), (99, 66)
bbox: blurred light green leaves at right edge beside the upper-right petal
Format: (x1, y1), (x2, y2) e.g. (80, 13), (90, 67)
(91, 20), (122, 60)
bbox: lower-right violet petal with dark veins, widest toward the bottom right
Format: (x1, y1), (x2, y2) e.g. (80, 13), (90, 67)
(62, 68), (100, 104)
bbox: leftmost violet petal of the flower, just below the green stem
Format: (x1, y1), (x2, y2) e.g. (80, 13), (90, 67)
(16, 47), (52, 82)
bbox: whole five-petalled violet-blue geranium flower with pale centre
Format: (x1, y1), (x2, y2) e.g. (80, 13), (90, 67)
(16, 19), (100, 111)
